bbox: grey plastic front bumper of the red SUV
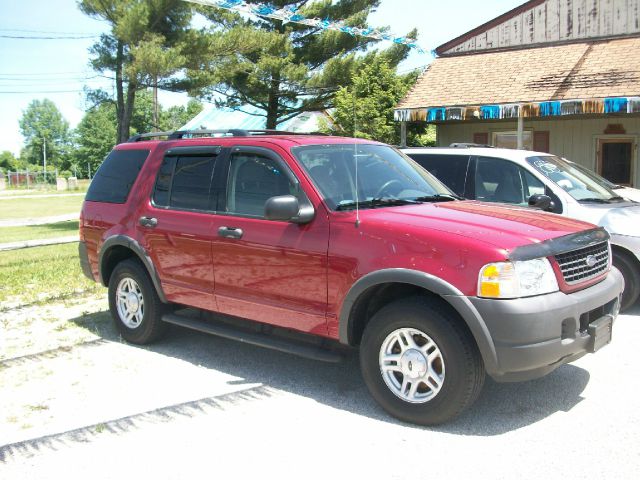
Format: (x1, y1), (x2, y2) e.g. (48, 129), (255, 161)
(469, 268), (624, 382)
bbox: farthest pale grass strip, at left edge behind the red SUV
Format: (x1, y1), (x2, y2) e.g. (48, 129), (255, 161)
(0, 196), (84, 220)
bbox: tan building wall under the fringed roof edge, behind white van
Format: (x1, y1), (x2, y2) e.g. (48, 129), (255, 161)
(437, 116), (640, 188)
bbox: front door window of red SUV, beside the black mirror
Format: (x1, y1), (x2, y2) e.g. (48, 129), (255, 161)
(227, 153), (296, 217)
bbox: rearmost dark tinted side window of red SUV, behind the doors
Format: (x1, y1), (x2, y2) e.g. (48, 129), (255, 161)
(85, 150), (149, 203)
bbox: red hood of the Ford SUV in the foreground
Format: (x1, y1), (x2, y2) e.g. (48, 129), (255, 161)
(360, 201), (594, 250)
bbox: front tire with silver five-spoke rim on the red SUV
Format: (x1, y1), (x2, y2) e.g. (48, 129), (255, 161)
(360, 297), (485, 425)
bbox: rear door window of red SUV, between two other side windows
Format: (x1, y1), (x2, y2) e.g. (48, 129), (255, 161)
(153, 156), (215, 210)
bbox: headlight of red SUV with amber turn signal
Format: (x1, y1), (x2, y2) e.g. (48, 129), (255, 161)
(478, 258), (558, 298)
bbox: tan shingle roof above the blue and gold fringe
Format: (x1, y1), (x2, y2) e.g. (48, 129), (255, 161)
(396, 38), (640, 109)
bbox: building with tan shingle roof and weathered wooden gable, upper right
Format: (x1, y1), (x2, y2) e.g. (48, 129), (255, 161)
(395, 0), (640, 186)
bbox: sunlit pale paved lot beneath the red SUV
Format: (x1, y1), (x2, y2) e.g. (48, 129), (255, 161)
(0, 302), (640, 479)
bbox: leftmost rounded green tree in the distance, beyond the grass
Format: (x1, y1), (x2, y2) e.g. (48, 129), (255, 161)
(20, 98), (71, 167)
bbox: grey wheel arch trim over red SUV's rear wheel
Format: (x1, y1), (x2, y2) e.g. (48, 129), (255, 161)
(98, 235), (168, 303)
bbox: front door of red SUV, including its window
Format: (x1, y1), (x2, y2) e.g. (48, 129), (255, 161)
(213, 147), (329, 334)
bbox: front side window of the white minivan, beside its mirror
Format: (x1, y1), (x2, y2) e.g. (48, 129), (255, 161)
(475, 157), (528, 205)
